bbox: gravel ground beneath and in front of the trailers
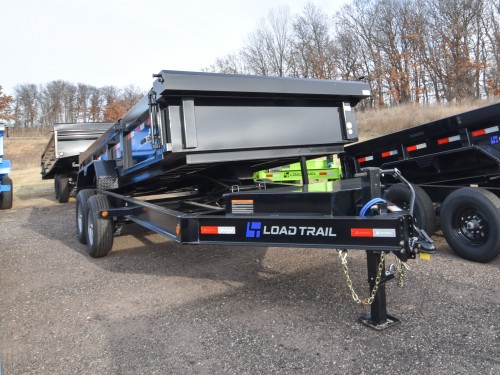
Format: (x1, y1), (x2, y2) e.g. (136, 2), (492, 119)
(0, 200), (500, 375)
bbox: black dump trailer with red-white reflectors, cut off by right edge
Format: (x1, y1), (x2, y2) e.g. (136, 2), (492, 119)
(341, 103), (500, 262)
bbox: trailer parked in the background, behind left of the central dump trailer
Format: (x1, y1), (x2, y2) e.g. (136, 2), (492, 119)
(41, 122), (114, 203)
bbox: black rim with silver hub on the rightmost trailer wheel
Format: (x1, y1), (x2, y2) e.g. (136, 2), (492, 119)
(453, 208), (490, 246)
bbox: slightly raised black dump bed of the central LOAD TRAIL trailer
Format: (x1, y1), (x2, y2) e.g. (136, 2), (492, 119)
(78, 71), (369, 192)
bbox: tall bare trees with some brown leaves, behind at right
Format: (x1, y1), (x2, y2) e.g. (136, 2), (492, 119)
(206, 0), (500, 107)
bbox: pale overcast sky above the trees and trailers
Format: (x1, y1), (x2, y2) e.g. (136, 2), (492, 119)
(0, 0), (346, 95)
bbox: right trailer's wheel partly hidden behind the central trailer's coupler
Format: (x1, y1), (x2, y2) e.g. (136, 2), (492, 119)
(384, 184), (436, 236)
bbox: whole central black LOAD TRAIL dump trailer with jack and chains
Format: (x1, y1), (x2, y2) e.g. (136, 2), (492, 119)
(76, 71), (433, 329)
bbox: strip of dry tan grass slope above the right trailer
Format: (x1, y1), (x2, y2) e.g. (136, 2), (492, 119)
(356, 98), (500, 140)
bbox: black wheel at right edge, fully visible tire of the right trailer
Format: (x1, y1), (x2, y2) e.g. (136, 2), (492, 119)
(441, 188), (500, 262)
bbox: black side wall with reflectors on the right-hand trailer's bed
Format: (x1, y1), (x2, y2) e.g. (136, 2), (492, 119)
(342, 103), (500, 184)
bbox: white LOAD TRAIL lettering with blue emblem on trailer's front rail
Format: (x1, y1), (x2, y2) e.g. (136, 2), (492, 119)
(246, 221), (337, 238)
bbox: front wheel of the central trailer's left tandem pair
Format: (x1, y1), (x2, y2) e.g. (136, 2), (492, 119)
(87, 194), (114, 258)
